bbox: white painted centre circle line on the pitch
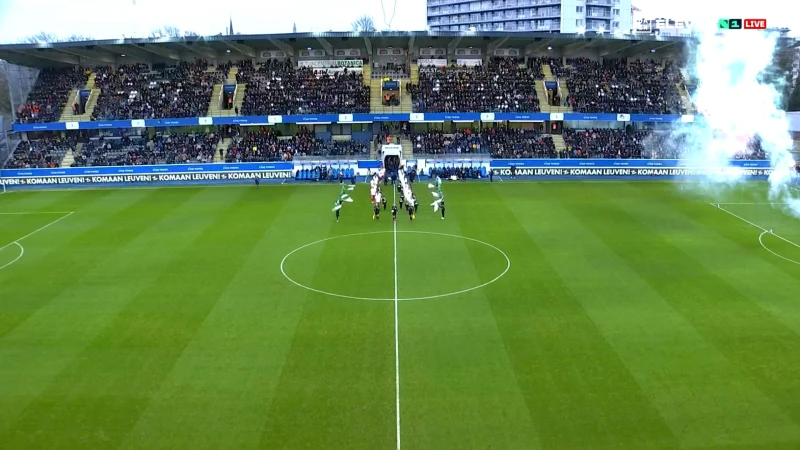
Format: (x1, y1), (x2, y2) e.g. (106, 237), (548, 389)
(280, 230), (511, 301)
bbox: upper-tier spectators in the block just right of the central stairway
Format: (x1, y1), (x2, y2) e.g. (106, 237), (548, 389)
(407, 57), (544, 112)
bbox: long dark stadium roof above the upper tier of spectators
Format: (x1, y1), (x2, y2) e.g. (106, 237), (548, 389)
(0, 31), (704, 68)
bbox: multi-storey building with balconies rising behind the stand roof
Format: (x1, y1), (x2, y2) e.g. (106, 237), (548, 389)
(427, 0), (632, 33)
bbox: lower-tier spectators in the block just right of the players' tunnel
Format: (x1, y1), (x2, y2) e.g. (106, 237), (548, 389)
(412, 126), (557, 158)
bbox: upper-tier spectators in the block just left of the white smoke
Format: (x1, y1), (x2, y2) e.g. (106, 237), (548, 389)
(564, 58), (682, 114)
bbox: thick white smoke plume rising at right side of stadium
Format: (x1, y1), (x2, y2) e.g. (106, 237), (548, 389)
(664, 21), (800, 218)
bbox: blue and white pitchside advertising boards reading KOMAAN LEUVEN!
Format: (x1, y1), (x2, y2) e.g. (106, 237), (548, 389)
(0, 159), (772, 189)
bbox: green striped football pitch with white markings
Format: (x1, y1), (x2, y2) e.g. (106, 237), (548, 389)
(0, 181), (800, 450)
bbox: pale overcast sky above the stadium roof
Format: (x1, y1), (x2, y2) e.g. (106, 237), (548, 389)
(0, 0), (800, 43)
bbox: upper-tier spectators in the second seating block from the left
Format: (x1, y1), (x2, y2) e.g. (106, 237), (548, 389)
(92, 60), (227, 120)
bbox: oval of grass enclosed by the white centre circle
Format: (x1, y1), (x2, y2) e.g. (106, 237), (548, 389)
(281, 230), (510, 301)
